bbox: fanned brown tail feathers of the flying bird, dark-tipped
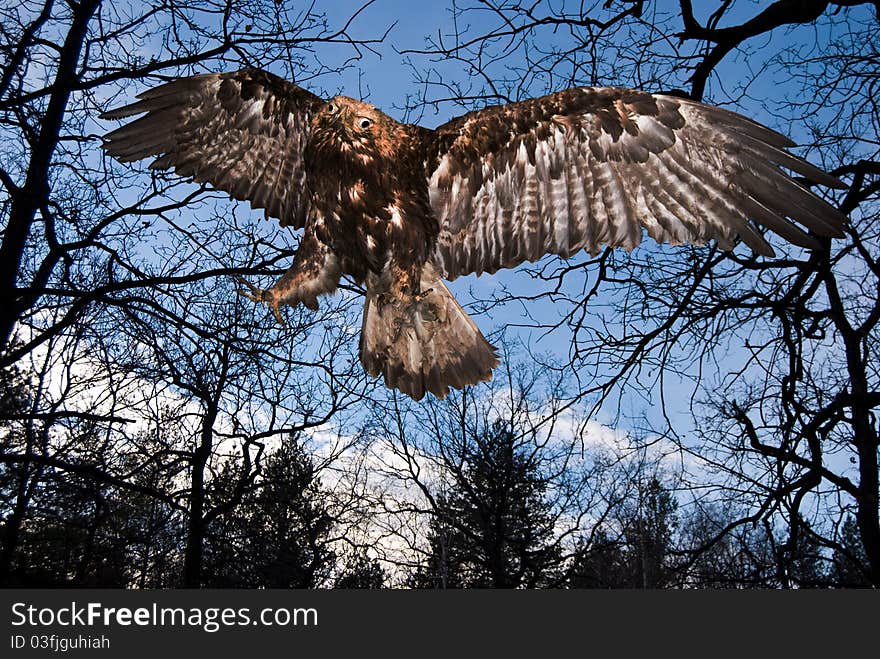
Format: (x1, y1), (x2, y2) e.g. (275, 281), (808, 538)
(360, 264), (499, 400)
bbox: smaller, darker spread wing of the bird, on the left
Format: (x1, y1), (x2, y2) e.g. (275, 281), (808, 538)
(102, 69), (323, 228)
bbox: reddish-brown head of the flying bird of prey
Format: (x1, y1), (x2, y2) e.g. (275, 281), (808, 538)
(311, 96), (399, 164)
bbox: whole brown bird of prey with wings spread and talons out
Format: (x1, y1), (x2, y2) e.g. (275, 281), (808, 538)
(102, 68), (845, 400)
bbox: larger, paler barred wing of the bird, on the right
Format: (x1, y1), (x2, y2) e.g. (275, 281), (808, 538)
(428, 87), (845, 279)
